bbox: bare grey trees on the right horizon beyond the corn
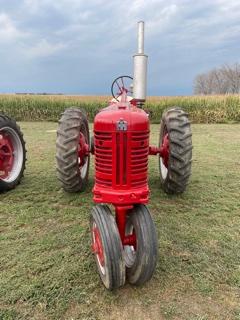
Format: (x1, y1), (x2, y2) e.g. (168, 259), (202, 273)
(194, 63), (240, 94)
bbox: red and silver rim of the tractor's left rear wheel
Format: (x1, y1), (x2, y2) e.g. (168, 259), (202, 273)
(78, 126), (89, 179)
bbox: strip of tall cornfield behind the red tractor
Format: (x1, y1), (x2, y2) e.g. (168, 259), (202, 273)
(0, 94), (240, 123)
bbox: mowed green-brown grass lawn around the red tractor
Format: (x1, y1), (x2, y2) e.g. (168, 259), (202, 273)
(0, 122), (240, 320)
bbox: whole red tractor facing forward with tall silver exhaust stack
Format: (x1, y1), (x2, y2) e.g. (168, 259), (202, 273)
(56, 21), (192, 289)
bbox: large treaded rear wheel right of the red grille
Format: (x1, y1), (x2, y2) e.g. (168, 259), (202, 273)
(159, 108), (192, 194)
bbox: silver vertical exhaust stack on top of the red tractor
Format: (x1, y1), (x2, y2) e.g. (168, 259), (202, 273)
(133, 21), (148, 107)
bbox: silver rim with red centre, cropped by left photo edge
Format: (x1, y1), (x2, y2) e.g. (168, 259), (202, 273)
(0, 127), (23, 182)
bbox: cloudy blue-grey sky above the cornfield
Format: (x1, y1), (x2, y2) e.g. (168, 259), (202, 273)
(0, 0), (240, 95)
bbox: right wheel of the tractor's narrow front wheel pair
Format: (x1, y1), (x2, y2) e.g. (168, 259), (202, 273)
(124, 205), (158, 285)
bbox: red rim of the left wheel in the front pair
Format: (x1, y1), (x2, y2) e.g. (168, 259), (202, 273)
(92, 222), (106, 275)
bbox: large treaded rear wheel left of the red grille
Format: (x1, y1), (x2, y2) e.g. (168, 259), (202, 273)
(56, 108), (90, 192)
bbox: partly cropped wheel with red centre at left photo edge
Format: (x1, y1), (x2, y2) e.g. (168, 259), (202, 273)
(0, 115), (26, 191)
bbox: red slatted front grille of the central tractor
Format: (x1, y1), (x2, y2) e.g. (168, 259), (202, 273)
(94, 131), (149, 189)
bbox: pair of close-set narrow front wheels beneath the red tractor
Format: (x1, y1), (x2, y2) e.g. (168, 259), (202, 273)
(91, 205), (158, 290)
